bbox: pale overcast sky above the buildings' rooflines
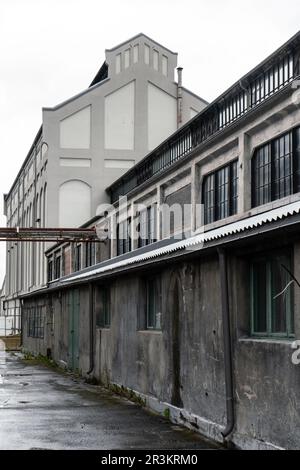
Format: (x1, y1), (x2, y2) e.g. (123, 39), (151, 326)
(0, 0), (300, 282)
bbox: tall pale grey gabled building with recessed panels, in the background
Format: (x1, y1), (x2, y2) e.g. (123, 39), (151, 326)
(4, 33), (207, 330)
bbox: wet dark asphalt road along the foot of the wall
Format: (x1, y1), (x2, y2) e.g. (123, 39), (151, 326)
(0, 354), (218, 450)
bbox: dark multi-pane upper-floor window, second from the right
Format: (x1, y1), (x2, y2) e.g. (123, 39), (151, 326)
(203, 161), (238, 224)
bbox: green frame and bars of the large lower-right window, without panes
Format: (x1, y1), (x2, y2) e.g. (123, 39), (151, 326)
(250, 249), (295, 340)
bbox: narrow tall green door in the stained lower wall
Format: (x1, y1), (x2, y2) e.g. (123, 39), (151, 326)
(68, 289), (80, 370)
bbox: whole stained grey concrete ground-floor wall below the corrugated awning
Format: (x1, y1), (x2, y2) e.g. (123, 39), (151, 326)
(23, 240), (300, 449)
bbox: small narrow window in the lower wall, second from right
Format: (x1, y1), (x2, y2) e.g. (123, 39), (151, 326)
(146, 277), (161, 330)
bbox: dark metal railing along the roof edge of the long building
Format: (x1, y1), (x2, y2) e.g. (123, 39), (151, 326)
(109, 45), (299, 203)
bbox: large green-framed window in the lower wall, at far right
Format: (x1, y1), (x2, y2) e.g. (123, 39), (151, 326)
(251, 252), (294, 337)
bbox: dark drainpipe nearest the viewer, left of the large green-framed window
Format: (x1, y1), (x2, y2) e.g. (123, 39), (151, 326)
(218, 248), (235, 439)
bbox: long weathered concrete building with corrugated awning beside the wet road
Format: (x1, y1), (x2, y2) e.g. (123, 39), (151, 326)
(4, 33), (300, 449)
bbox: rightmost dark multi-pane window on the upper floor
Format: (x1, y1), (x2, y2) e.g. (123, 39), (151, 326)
(252, 128), (300, 207)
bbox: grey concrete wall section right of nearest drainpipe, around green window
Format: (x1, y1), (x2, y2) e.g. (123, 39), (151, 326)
(230, 248), (300, 449)
